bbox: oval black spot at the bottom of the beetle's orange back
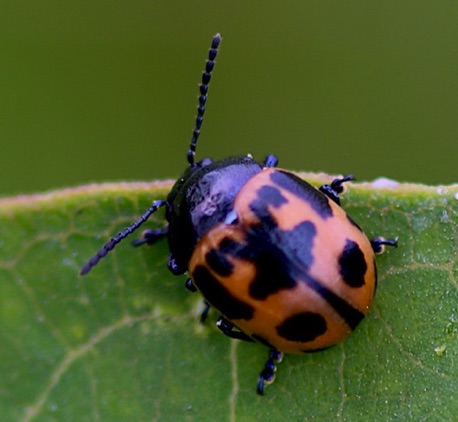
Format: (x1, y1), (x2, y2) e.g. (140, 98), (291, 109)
(277, 312), (327, 343)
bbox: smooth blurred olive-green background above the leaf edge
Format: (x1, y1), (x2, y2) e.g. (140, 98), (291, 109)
(0, 0), (458, 195)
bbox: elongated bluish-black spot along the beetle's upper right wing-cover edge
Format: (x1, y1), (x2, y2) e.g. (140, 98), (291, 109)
(270, 170), (333, 219)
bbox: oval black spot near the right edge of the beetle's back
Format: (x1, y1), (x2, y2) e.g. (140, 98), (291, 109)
(339, 239), (367, 288)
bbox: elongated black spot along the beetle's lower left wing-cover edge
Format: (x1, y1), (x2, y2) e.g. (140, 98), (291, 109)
(192, 265), (254, 320)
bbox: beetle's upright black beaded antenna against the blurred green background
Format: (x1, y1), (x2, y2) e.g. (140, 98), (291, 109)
(187, 34), (221, 166)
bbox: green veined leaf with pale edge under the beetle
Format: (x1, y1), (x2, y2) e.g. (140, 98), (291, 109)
(0, 175), (458, 421)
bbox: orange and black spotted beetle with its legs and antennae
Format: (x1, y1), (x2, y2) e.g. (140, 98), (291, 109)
(80, 34), (397, 394)
